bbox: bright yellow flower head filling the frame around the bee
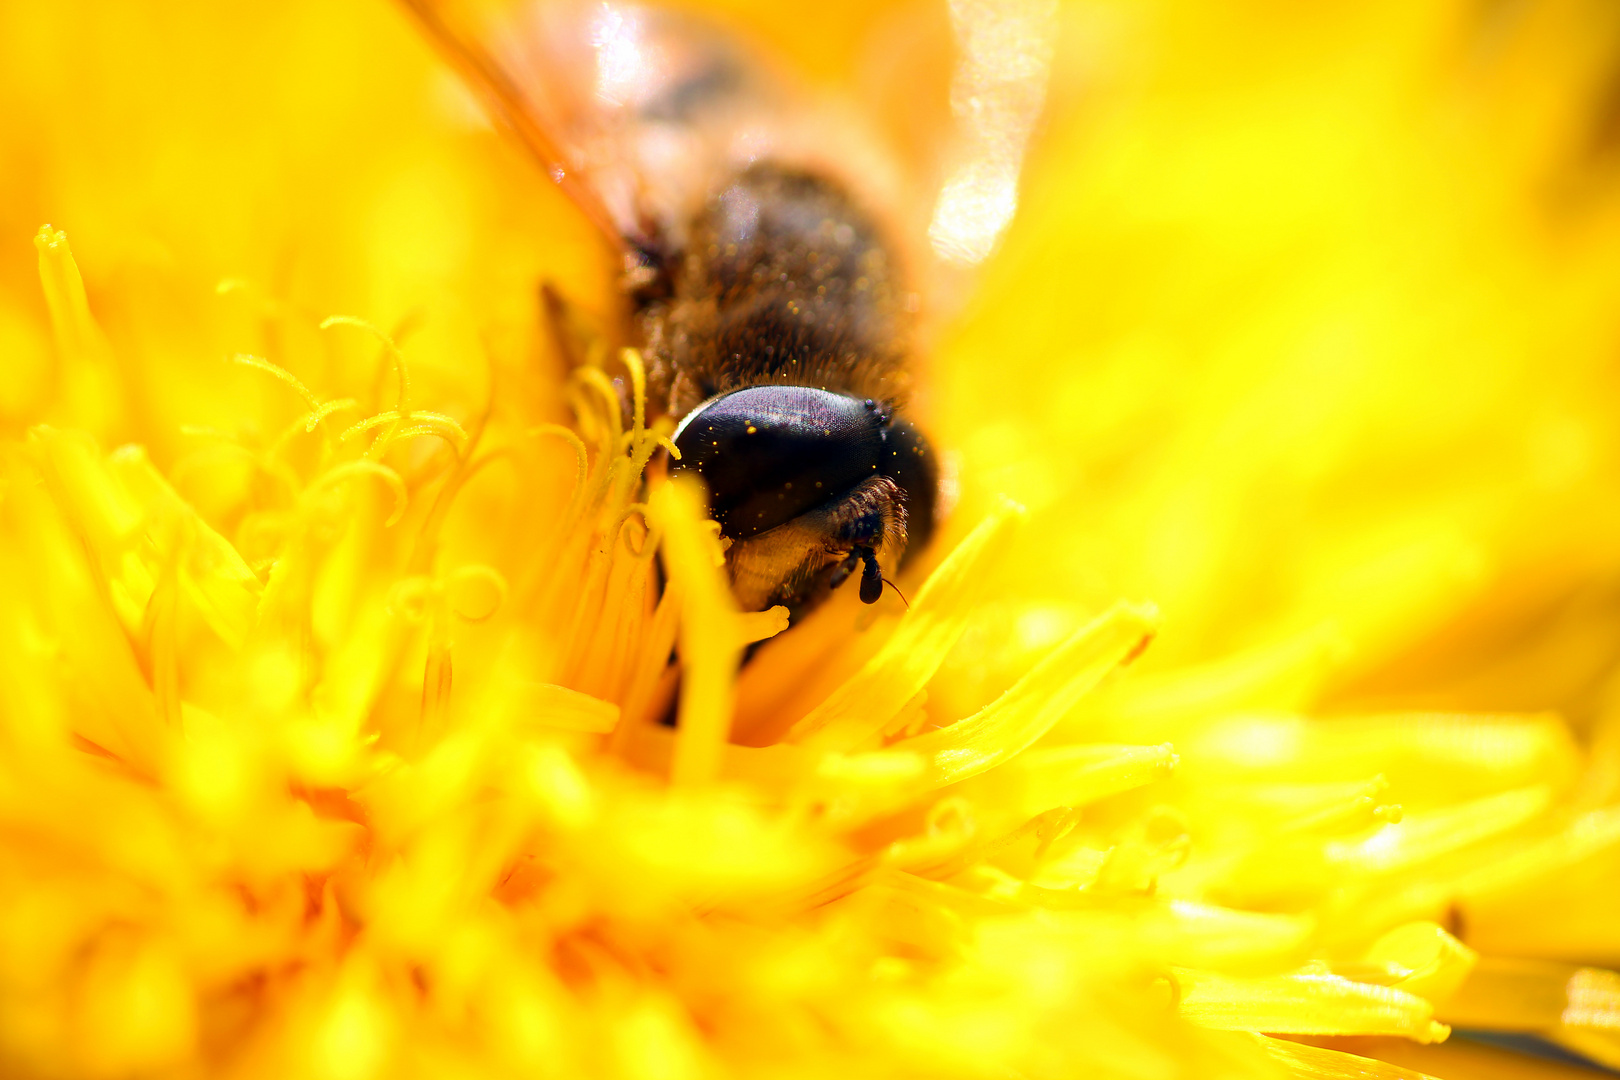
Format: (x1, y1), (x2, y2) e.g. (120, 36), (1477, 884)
(9, 0), (1620, 1080)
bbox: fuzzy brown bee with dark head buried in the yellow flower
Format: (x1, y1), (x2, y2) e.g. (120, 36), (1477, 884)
(403, 0), (1055, 620)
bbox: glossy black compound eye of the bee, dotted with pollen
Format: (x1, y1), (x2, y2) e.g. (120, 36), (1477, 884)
(676, 385), (886, 539)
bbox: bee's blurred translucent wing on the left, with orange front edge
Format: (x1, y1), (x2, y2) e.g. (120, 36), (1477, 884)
(400, 0), (803, 262)
